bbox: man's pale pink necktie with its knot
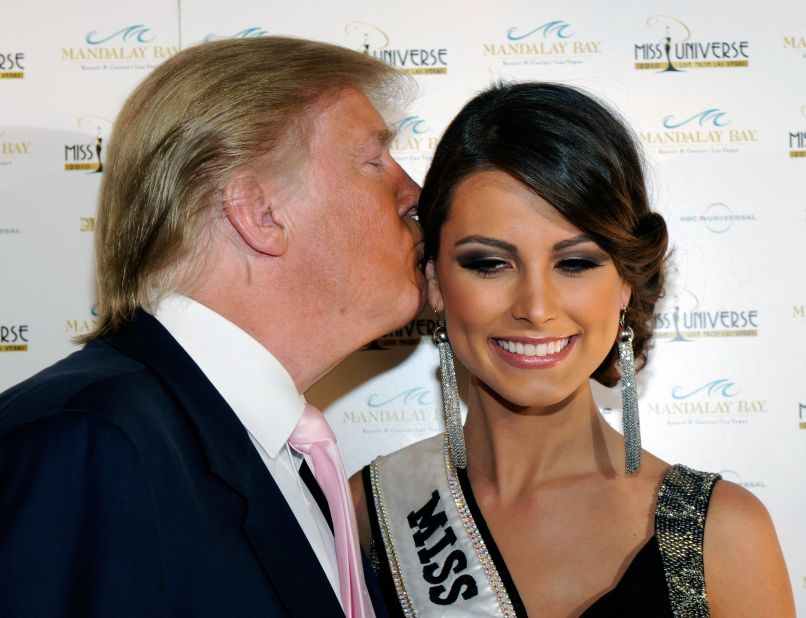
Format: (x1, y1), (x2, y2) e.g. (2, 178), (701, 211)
(288, 405), (375, 618)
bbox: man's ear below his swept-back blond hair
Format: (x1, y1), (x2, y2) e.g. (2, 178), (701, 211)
(224, 171), (288, 256)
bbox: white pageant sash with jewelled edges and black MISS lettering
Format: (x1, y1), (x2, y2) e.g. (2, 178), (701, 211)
(370, 434), (515, 618)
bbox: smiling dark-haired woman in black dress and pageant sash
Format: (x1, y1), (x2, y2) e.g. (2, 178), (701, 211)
(352, 84), (794, 616)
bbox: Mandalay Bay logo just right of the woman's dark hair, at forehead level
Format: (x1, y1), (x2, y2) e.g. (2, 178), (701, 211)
(638, 107), (759, 155)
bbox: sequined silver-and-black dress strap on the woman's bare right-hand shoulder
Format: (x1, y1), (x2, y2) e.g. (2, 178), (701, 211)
(655, 464), (721, 618)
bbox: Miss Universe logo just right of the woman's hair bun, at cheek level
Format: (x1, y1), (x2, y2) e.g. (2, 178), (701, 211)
(654, 288), (758, 343)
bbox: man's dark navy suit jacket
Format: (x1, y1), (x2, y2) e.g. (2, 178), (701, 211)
(0, 312), (385, 618)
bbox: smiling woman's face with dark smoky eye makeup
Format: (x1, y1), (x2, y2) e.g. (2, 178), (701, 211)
(426, 171), (630, 407)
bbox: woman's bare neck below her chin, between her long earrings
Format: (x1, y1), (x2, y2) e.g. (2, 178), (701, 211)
(465, 380), (623, 500)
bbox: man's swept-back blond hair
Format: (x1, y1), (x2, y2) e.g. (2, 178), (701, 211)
(79, 37), (411, 341)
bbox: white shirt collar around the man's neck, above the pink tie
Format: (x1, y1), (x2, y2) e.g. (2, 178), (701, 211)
(154, 294), (305, 459)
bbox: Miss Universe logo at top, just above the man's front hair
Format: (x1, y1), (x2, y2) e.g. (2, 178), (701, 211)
(344, 21), (448, 75)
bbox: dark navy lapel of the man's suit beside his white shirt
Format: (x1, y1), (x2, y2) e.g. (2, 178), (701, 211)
(103, 310), (342, 616)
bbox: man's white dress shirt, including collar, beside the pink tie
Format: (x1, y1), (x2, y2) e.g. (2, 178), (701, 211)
(154, 294), (343, 606)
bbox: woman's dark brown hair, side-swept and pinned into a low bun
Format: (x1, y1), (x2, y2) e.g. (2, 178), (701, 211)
(419, 83), (668, 386)
